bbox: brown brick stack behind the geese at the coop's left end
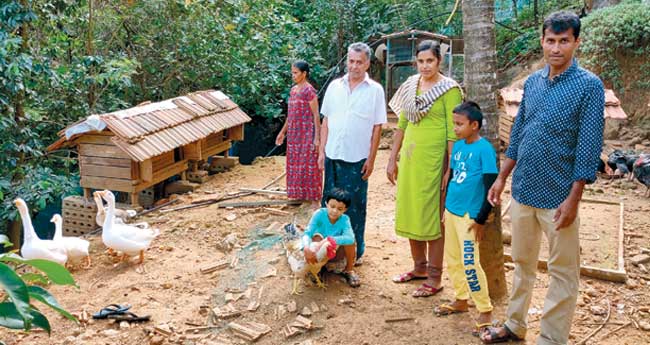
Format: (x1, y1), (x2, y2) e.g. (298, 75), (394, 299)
(62, 195), (98, 236)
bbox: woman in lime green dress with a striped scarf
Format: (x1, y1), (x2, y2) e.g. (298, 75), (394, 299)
(386, 40), (463, 297)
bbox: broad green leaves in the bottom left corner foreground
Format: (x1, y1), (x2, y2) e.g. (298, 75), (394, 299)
(0, 254), (77, 334)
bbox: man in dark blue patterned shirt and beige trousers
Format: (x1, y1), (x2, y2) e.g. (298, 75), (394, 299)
(480, 12), (605, 345)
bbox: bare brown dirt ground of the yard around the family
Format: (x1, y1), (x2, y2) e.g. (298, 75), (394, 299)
(0, 146), (650, 345)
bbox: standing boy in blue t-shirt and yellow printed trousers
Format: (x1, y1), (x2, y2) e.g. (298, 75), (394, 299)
(434, 101), (498, 332)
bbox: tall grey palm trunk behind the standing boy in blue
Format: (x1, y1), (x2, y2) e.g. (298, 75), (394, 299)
(463, 0), (507, 300)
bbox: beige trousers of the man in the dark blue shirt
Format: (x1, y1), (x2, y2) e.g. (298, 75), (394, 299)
(506, 199), (580, 345)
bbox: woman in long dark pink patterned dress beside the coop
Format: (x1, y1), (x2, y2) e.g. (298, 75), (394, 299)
(275, 61), (323, 209)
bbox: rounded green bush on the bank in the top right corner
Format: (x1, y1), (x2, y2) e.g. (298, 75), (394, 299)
(580, 0), (650, 93)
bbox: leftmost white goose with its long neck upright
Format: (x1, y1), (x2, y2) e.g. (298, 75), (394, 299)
(14, 198), (68, 265)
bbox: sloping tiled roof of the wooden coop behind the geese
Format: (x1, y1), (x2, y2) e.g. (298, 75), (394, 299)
(48, 90), (251, 162)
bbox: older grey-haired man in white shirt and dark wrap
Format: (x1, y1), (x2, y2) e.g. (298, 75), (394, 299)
(318, 43), (386, 282)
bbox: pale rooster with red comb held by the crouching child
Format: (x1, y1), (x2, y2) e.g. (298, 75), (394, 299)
(285, 231), (336, 295)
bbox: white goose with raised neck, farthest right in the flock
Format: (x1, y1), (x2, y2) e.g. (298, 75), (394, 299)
(95, 190), (160, 263)
